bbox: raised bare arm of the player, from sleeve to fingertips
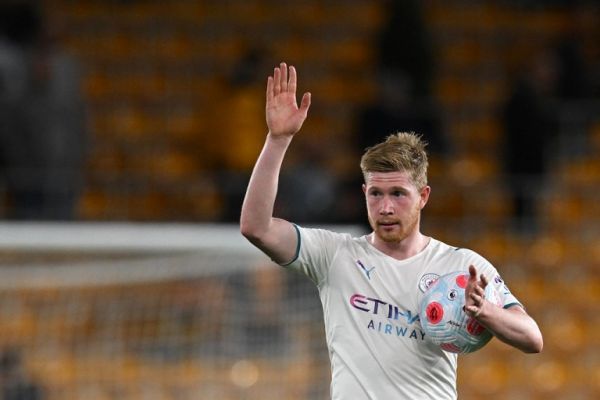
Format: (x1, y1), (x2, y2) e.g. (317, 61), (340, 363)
(240, 63), (310, 263)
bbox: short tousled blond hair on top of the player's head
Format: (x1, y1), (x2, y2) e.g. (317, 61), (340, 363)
(360, 132), (429, 189)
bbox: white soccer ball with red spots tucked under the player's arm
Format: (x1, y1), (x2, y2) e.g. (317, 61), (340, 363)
(419, 271), (501, 353)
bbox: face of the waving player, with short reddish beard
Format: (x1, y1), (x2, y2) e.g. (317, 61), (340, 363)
(363, 171), (431, 242)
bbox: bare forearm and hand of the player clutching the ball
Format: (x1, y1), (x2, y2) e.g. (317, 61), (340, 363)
(465, 265), (544, 353)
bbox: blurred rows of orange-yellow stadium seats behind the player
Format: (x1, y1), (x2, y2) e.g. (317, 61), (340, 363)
(0, 0), (600, 400)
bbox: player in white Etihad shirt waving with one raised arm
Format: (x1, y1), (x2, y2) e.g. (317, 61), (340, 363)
(241, 63), (543, 400)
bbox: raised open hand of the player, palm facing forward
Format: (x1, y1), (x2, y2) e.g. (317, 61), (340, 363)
(266, 62), (310, 137)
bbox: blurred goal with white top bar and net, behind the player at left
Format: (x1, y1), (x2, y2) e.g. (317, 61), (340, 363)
(0, 223), (356, 400)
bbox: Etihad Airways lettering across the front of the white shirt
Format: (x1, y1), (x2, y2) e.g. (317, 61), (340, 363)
(350, 293), (425, 340)
